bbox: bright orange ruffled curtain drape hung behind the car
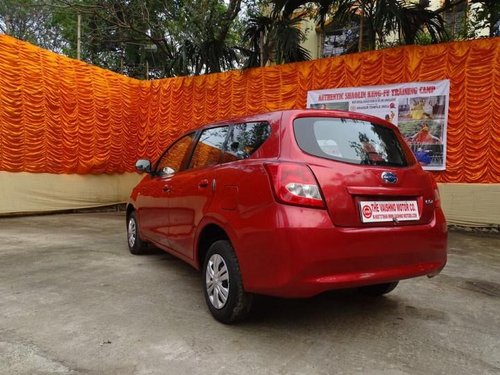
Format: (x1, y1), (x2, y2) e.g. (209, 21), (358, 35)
(0, 35), (500, 183)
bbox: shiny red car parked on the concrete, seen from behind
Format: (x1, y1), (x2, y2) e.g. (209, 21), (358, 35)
(127, 110), (447, 323)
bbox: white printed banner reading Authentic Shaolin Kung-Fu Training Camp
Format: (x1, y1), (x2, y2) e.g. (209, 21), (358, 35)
(307, 80), (450, 170)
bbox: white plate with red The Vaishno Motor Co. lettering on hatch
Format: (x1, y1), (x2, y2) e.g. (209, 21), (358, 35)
(359, 200), (420, 223)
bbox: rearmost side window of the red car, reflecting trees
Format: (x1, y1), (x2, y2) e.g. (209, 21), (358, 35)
(224, 122), (271, 162)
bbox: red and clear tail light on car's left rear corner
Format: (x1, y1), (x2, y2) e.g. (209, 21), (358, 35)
(266, 163), (325, 208)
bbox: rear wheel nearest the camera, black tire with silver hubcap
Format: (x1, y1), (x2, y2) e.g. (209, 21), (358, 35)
(202, 240), (253, 324)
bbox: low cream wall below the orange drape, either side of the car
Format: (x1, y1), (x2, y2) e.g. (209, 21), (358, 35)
(0, 172), (500, 226)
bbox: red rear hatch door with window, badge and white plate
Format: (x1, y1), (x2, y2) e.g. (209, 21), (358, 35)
(293, 117), (434, 227)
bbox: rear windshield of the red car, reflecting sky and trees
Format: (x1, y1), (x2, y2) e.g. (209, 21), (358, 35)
(293, 117), (409, 167)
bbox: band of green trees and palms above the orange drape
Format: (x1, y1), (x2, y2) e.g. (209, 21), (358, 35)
(0, 0), (500, 78)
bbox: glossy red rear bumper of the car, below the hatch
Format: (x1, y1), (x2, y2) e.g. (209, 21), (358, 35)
(237, 206), (447, 297)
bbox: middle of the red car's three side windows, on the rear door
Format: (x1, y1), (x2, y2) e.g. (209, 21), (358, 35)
(189, 126), (228, 168)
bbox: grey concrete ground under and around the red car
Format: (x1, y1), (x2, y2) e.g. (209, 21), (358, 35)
(0, 212), (500, 375)
